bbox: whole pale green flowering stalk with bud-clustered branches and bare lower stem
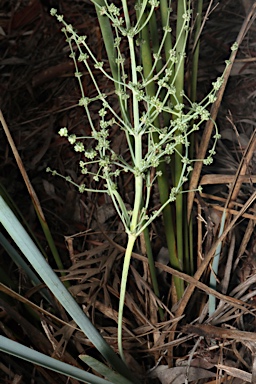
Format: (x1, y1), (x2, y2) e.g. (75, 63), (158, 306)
(48, 0), (232, 360)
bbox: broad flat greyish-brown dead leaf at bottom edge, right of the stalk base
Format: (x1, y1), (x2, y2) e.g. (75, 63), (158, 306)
(150, 365), (215, 384)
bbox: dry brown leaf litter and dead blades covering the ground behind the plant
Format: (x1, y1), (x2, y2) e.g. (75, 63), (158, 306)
(0, 0), (256, 384)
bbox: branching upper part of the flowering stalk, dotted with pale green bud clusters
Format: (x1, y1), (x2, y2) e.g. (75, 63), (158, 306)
(48, 1), (229, 236)
